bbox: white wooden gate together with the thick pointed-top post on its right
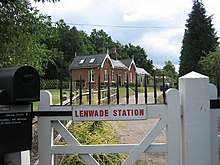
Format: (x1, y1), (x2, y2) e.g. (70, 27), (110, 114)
(38, 72), (219, 165)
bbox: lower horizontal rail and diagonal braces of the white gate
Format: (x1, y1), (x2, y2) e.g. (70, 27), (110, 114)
(52, 117), (166, 164)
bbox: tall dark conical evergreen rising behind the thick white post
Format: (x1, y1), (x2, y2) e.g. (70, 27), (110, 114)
(179, 0), (219, 76)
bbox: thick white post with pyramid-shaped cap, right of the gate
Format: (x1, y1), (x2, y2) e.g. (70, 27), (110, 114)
(179, 72), (211, 165)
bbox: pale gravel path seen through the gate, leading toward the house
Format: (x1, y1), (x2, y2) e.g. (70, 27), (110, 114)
(112, 93), (166, 165)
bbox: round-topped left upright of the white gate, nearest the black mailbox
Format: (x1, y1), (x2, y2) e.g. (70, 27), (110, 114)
(38, 91), (54, 165)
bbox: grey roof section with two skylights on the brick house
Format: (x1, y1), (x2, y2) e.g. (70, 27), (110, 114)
(69, 53), (113, 69)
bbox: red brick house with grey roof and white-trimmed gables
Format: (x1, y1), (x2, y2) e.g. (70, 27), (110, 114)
(69, 53), (136, 87)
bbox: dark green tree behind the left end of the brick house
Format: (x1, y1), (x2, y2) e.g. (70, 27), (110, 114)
(44, 20), (95, 80)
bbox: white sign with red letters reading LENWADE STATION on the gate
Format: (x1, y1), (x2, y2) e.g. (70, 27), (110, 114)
(72, 104), (147, 121)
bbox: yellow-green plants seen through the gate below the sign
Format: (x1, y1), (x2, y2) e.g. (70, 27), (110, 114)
(65, 121), (125, 165)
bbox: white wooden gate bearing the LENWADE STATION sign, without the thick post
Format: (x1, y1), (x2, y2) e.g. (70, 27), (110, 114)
(38, 89), (180, 165)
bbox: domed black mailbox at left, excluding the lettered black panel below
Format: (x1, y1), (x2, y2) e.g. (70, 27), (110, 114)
(0, 66), (40, 104)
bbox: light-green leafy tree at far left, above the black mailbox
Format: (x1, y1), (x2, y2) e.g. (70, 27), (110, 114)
(0, 0), (53, 74)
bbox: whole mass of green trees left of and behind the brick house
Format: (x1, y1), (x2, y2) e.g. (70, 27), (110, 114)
(0, 0), (153, 80)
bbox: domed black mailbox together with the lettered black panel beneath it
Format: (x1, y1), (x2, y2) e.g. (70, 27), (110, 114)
(0, 66), (40, 155)
